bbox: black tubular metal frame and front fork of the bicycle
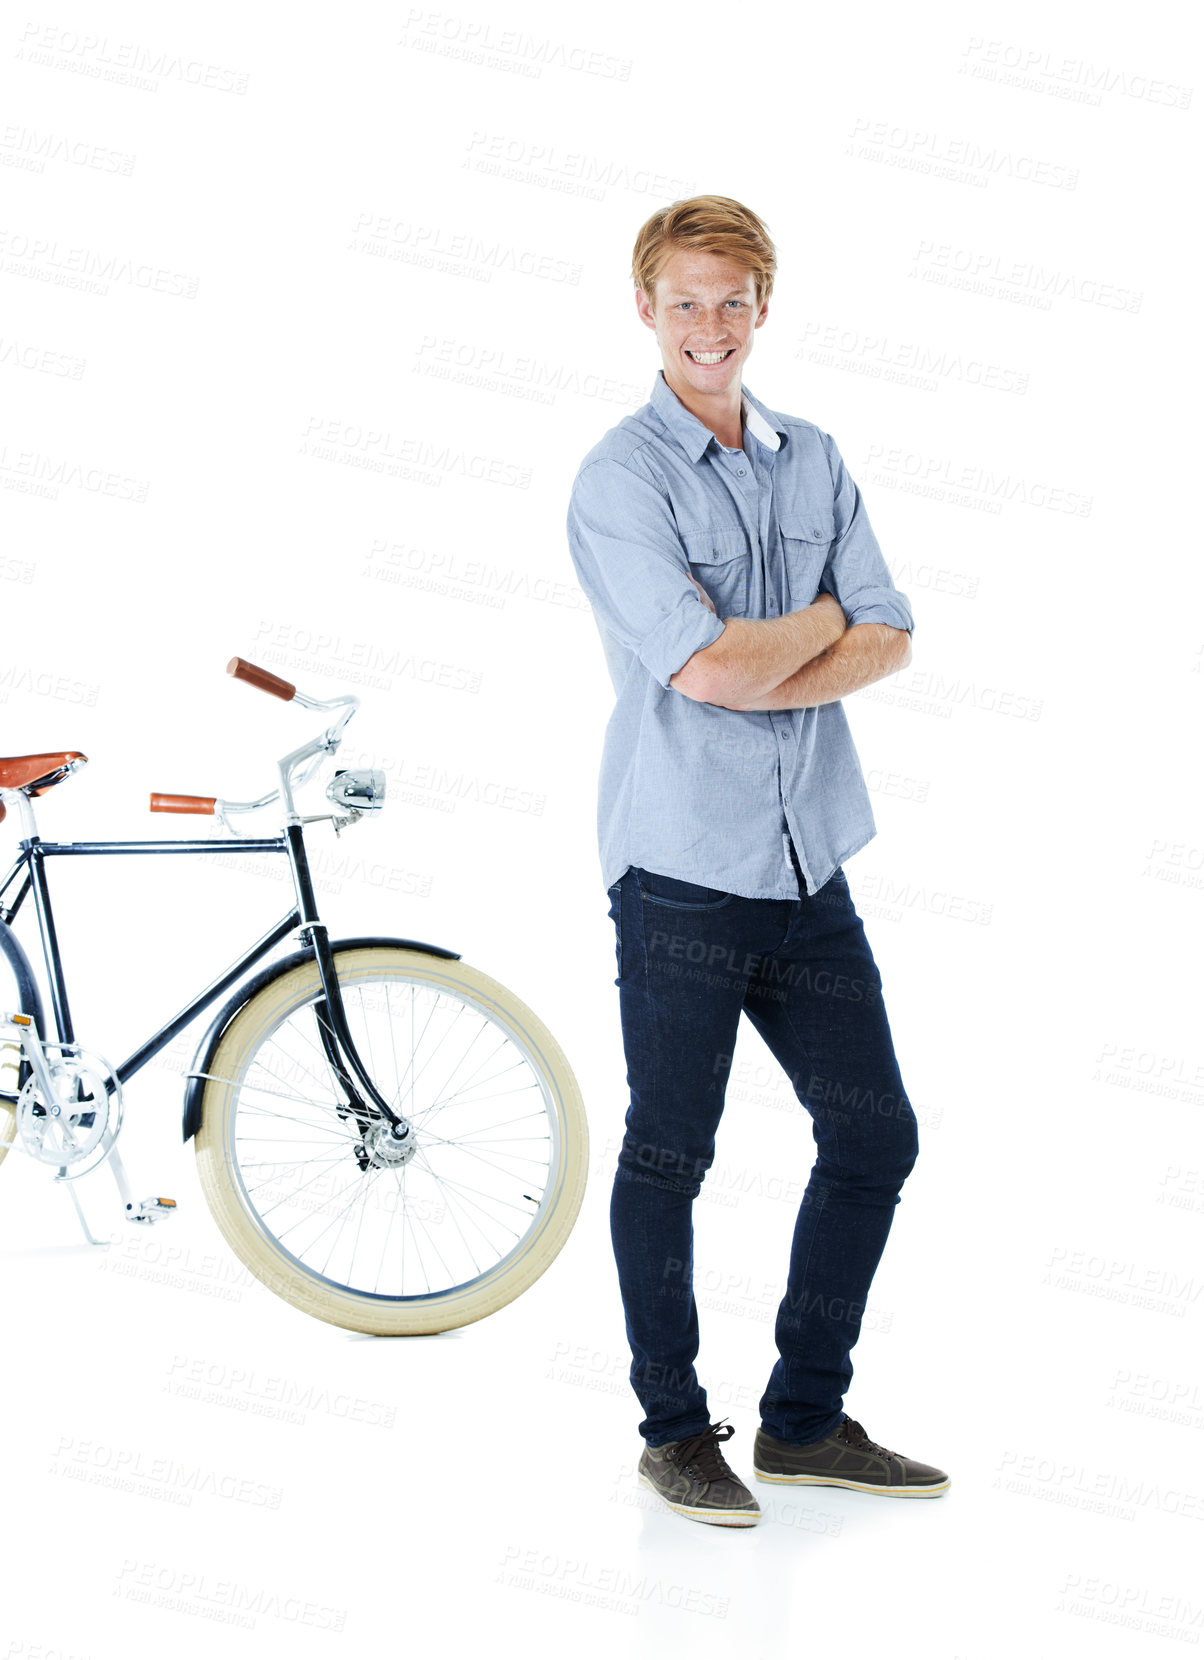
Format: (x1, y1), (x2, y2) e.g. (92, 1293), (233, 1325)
(0, 825), (402, 1127)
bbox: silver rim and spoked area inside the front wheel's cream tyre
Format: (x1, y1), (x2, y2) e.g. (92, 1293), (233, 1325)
(216, 968), (563, 1303)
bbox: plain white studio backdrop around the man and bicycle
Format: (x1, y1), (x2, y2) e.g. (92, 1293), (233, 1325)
(0, 0), (1204, 1660)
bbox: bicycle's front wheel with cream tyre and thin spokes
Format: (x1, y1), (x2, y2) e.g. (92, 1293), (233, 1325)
(196, 943), (588, 1336)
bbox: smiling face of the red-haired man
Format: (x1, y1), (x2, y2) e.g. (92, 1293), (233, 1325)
(636, 247), (769, 411)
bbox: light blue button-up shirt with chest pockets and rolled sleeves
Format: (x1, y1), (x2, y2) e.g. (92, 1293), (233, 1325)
(568, 370), (913, 900)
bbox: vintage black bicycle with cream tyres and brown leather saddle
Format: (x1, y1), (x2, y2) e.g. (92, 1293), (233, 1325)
(0, 657), (588, 1335)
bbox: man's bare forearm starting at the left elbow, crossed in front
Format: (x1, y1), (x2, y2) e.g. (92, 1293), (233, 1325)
(669, 594), (845, 709)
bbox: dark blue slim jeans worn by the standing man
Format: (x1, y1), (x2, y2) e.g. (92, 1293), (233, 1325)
(609, 865), (918, 1446)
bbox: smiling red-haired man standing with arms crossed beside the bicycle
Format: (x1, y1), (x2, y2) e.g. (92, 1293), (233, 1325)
(568, 196), (950, 1527)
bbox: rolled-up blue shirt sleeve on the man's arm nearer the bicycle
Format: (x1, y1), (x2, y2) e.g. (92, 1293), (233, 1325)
(568, 458), (724, 687)
